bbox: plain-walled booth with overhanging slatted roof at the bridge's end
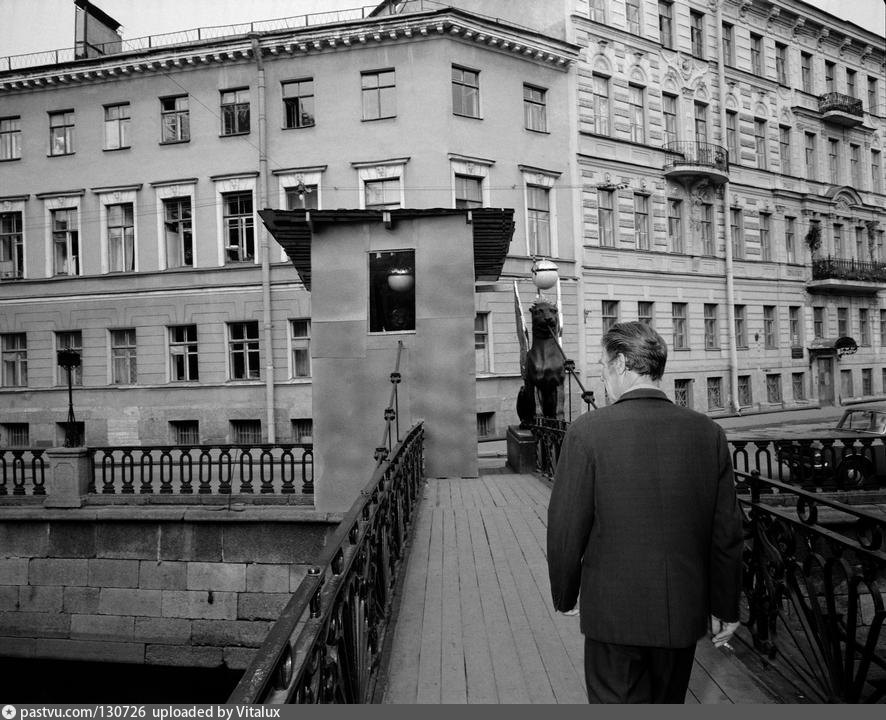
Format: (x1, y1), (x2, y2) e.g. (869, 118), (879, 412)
(259, 208), (514, 511)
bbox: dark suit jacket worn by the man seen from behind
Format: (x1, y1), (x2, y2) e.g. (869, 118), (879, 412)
(547, 389), (743, 648)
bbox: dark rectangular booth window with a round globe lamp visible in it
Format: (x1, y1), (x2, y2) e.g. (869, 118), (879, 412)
(369, 250), (415, 332)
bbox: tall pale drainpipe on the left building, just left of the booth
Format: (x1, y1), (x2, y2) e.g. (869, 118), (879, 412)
(249, 33), (277, 443)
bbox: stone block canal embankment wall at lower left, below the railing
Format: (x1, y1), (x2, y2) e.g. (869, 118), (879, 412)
(0, 505), (338, 670)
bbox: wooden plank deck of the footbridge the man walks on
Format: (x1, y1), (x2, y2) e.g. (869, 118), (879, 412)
(378, 473), (781, 704)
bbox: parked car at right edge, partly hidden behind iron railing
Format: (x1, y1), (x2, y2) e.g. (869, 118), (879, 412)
(776, 405), (886, 490)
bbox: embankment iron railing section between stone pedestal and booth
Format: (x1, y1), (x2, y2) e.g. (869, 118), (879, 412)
(87, 443), (314, 495)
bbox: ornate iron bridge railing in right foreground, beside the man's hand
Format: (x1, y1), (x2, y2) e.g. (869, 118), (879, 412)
(737, 470), (886, 703)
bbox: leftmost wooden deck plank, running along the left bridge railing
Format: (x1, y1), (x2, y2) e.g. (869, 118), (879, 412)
(383, 490), (431, 704)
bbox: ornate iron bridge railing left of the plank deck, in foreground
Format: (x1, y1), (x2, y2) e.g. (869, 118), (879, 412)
(228, 423), (424, 704)
